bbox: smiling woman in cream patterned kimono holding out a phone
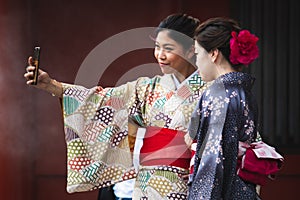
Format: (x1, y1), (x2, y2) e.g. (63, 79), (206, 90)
(24, 14), (209, 199)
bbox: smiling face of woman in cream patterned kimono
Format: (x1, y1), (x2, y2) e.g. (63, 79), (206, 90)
(154, 30), (192, 77)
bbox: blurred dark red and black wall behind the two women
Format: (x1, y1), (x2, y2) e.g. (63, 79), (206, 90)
(0, 0), (300, 200)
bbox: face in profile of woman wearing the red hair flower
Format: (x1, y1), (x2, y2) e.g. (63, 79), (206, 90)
(195, 41), (218, 82)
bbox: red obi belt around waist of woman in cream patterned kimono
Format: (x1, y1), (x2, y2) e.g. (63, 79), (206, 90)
(140, 127), (191, 169)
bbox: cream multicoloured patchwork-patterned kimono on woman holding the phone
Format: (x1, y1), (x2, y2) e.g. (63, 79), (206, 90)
(63, 73), (204, 199)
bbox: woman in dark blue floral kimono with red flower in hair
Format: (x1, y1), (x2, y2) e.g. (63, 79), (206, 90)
(188, 18), (259, 200)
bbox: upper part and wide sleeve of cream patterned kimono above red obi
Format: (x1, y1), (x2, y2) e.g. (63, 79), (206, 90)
(62, 73), (205, 193)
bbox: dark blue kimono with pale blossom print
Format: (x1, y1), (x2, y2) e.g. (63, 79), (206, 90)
(188, 72), (259, 200)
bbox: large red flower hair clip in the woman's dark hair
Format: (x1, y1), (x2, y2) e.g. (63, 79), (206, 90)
(229, 30), (259, 65)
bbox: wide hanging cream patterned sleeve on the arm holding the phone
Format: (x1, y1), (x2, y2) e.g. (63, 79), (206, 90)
(62, 82), (136, 193)
